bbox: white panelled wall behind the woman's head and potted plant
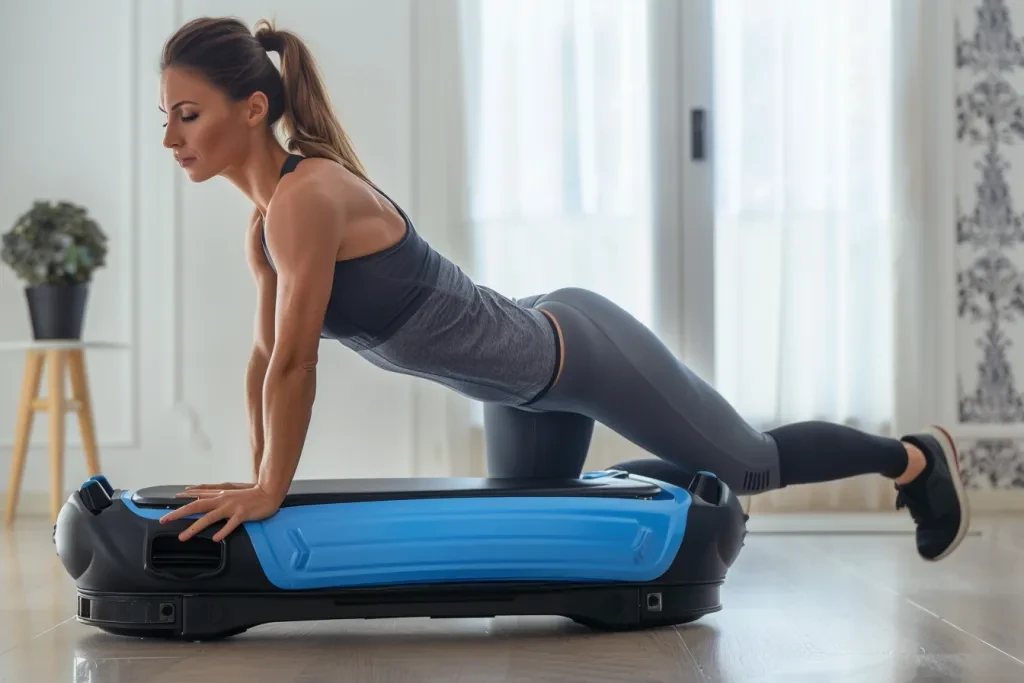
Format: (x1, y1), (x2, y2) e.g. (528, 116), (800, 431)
(0, 0), (471, 499)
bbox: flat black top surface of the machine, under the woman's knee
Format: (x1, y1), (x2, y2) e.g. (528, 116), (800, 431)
(132, 473), (662, 508)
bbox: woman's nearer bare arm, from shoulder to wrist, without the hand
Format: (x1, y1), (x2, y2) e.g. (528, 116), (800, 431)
(258, 183), (344, 501)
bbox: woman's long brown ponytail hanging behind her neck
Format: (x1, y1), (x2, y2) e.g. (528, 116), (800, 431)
(255, 19), (370, 182)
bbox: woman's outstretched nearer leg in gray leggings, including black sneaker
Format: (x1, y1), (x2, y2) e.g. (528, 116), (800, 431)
(527, 288), (967, 557)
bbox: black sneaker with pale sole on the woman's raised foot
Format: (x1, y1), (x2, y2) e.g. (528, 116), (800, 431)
(896, 426), (971, 561)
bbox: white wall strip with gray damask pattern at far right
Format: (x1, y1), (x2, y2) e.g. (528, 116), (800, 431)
(954, 0), (1024, 488)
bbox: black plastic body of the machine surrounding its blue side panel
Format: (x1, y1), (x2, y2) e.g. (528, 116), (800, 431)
(54, 462), (746, 640)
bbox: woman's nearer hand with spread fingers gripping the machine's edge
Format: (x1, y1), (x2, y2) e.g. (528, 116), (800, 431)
(160, 484), (284, 542)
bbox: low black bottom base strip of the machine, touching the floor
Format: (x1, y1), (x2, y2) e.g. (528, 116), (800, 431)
(78, 583), (722, 640)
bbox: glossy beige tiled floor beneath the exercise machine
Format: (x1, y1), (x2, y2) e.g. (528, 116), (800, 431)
(0, 518), (1024, 683)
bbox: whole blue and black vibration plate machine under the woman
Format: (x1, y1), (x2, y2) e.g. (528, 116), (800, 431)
(53, 468), (746, 640)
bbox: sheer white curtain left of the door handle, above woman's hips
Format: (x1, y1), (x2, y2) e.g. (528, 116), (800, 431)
(460, 0), (653, 324)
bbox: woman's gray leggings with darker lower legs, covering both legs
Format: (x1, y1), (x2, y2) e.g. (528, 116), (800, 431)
(484, 288), (906, 495)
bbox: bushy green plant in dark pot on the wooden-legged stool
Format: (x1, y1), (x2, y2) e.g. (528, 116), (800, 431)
(0, 201), (106, 339)
